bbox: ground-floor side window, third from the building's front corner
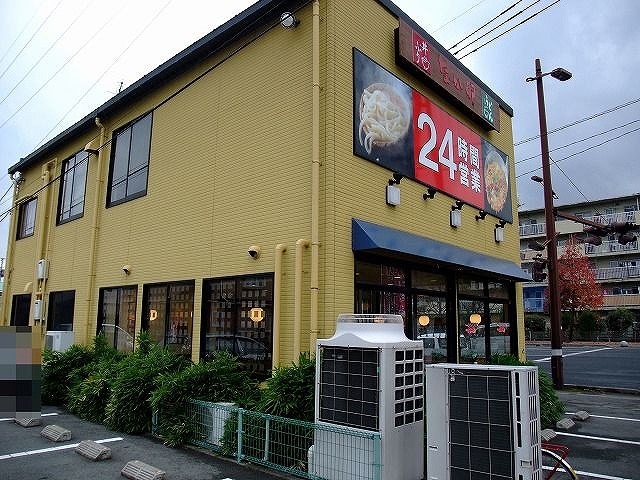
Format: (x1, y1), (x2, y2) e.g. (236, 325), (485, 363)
(97, 285), (138, 352)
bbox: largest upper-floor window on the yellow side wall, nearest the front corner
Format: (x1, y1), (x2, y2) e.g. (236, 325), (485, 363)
(107, 113), (153, 207)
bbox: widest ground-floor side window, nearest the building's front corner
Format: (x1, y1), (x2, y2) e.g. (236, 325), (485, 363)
(200, 274), (273, 375)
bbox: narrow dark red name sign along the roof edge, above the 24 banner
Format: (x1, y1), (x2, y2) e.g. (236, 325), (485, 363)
(398, 20), (500, 131)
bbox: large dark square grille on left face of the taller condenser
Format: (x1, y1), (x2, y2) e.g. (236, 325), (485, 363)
(319, 346), (380, 430)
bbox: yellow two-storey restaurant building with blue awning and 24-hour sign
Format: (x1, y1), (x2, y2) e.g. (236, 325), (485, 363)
(1, 0), (528, 372)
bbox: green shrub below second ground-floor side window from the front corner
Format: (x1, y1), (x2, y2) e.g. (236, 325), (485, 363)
(104, 345), (190, 434)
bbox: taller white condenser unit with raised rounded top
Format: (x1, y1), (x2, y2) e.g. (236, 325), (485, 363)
(309, 314), (424, 480)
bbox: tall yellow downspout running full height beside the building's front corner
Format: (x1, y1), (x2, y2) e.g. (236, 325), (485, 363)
(309, 0), (320, 352)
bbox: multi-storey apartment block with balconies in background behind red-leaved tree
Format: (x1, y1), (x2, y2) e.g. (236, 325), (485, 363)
(519, 194), (640, 313)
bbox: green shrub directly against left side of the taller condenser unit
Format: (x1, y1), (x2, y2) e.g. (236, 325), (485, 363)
(258, 352), (316, 422)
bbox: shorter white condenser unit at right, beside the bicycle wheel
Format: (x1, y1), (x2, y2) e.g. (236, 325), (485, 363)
(425, 364), (542, 480)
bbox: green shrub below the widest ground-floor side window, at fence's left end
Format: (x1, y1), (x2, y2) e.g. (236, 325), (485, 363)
(151, 352), (259, 447)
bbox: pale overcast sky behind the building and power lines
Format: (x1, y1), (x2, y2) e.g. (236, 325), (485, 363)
(0, 0), (640, 256)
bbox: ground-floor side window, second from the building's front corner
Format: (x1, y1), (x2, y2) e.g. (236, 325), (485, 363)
(142, 280), (195, 357)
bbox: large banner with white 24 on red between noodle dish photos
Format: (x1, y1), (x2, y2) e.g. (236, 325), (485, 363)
(353, 49), (513, 222)
